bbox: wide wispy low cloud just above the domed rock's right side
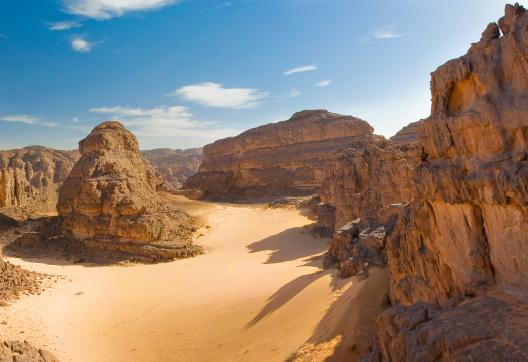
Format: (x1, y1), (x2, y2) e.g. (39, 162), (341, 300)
(90, 106), (241, 149)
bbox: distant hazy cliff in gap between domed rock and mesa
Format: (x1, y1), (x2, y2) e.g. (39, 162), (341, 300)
(141, 148), (203, 190)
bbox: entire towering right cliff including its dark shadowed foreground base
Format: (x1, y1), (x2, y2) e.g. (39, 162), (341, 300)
(369, 4), (528, 361)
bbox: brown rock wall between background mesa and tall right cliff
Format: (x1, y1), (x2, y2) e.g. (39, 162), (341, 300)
(319, 129), (417, 277)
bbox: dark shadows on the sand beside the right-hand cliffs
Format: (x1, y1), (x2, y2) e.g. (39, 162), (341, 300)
(244, 223), (388, 361)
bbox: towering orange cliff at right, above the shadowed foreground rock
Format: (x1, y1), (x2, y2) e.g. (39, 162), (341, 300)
(389, 5), (528, 304)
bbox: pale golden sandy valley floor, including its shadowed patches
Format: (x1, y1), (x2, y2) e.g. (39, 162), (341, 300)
(0, 200), (387, 361)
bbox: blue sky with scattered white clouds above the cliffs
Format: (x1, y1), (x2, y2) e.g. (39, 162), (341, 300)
(0, 0), (526, 149)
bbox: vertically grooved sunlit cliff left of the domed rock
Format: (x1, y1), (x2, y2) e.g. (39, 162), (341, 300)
(0, 146), (78, 219)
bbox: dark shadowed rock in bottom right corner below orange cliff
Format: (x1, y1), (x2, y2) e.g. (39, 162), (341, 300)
(363, 294), (528, 362)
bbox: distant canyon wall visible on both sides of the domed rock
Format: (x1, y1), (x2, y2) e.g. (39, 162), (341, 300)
(0, 146), (202, 219)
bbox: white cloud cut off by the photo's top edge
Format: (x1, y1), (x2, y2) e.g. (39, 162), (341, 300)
(62, 0), (179, 20)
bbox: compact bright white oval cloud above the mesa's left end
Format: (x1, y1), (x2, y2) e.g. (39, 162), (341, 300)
(170, 82), (268, 109)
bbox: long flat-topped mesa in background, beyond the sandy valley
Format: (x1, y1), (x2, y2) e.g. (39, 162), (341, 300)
(185, 110), (372, 198)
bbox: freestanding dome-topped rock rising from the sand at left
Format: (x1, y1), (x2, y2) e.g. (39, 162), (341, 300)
(57, 121), (200, 259)
